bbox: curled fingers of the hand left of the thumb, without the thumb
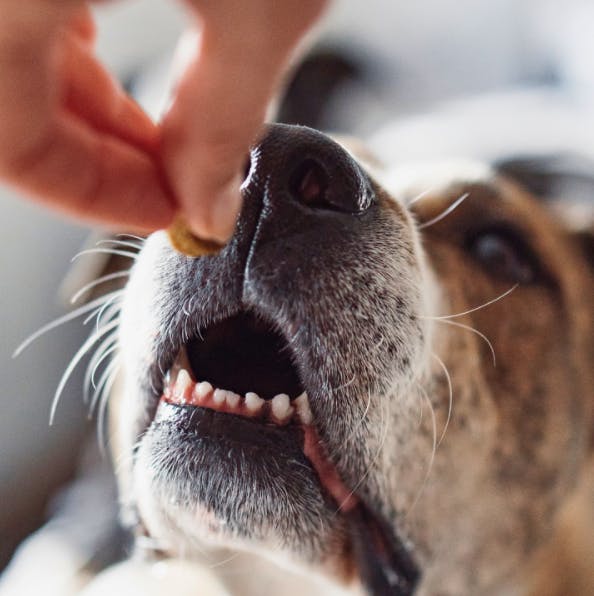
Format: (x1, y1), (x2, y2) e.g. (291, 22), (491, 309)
(0, 0), (174, 231)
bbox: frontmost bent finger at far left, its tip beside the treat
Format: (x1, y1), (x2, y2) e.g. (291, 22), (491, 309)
(0, 0), (173, 230)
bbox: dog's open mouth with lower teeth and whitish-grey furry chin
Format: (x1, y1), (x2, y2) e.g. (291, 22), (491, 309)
(134, 313), (354, 575)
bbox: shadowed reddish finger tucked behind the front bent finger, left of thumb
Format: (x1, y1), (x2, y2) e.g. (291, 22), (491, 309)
(60, 36), (159, 153)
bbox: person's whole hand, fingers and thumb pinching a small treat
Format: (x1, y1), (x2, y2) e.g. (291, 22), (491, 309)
(0, 0), (325, 242)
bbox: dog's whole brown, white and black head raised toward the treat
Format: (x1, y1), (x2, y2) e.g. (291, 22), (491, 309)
(112, 126), (594, 594)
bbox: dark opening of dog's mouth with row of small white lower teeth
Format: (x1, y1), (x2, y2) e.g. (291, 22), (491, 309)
(163, 313), (312, 426)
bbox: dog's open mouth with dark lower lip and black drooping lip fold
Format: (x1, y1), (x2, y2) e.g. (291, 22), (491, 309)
(156, 312), (418, 596)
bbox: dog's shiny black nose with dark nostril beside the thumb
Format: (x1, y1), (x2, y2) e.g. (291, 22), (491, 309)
(244, 124), (374, 214)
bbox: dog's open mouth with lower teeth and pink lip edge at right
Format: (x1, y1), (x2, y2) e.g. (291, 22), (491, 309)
(161, 313), (357, 510)
